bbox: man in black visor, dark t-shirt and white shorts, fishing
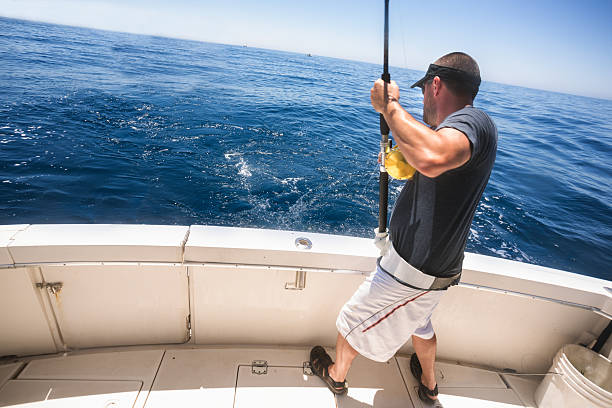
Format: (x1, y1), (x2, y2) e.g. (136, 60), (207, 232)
(310, 52), (497, 407)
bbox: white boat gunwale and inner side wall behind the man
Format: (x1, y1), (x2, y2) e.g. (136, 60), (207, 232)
(0, 224), (612, 373)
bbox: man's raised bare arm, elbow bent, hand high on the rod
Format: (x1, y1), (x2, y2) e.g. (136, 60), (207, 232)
(370, 79), (471, 178)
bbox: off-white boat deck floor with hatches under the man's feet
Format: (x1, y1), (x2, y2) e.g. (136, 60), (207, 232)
(0, 346), (541, 408)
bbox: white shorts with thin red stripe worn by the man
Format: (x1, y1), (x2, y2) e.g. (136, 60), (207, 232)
(336, 268), (446, 362)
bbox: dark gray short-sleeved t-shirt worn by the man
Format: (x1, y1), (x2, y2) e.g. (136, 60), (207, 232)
(389, 106), (497, 277)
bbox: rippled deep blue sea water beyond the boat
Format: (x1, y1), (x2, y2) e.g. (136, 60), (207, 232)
(0, 18), (612, 279)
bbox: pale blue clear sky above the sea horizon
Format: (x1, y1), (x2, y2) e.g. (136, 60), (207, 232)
(0, 0), (612, 99)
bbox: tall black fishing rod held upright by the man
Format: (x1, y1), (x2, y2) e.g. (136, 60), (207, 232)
(377, 0), (391, 237)
